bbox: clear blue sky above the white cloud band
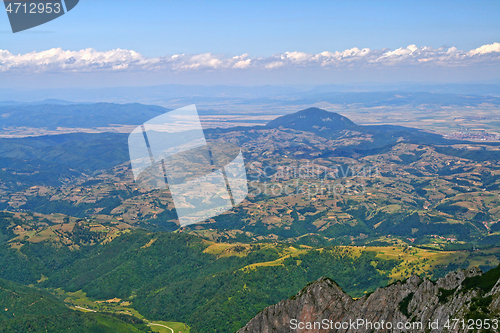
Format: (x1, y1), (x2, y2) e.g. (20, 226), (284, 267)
(0, 0), (500, 83)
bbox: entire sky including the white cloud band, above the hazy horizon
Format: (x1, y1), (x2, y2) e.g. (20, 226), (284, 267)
(0, 0), (500, 88)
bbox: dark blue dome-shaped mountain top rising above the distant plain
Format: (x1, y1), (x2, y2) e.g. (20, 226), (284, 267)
(266, 108), (357, 133)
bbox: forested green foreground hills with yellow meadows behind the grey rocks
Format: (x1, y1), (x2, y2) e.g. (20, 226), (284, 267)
(0, 214), (498, 333)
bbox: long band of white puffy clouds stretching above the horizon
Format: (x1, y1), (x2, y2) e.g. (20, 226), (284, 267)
(0, 43), (500, 73)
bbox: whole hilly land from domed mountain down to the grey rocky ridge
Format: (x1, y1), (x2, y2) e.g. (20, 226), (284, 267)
(0, 102), (500, 333)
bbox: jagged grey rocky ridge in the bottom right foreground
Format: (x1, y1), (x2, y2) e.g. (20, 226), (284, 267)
(238, 266), (500, 333)
